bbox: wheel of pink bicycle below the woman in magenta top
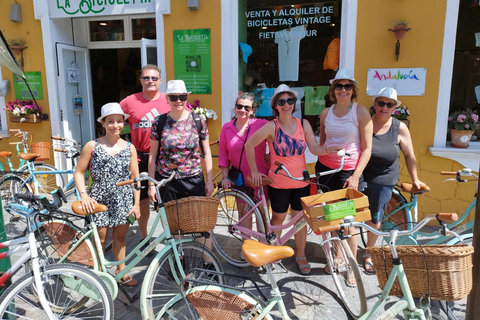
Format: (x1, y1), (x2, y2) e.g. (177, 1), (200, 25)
(212, 189), (265, 267)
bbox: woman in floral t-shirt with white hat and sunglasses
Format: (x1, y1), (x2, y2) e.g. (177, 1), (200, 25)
(148, 80), (213, 202)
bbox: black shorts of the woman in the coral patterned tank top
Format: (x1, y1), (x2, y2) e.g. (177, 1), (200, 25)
(268, 185), (310, 213)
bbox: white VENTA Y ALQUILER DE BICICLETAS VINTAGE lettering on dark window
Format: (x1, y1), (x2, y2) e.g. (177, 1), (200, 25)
(245, 3), (336, 39)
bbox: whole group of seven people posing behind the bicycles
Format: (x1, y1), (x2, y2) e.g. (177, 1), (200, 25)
(75, 65), (423, 285)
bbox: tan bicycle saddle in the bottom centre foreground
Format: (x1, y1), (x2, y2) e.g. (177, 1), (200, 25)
(242, 240), (294, 267)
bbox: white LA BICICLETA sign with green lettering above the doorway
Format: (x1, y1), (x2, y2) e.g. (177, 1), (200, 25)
(48, 0), (155, 18)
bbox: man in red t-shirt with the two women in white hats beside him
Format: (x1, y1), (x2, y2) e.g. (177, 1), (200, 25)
(75, 65), (213, 286)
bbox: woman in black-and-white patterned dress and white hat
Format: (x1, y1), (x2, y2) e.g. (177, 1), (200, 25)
(74, 102), (140, 286)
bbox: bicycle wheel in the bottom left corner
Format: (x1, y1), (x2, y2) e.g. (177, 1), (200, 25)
(0, 264), (114, 319)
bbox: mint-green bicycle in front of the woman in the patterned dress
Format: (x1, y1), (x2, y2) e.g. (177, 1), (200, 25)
(39, 165), (223, 319)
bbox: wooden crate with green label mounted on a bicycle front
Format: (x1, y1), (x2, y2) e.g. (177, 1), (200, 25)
(301, 188), (371, 234)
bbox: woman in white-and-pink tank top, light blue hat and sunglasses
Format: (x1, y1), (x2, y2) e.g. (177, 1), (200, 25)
(315, 69), (373, 278)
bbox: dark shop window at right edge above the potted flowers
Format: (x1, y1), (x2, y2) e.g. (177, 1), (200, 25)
(449, 0), (480, 141)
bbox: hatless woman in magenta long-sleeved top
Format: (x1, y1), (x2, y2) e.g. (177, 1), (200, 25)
(218, 93), (269, 228)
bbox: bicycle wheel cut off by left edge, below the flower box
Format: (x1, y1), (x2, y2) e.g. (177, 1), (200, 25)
(0, 175), (27, 240)
